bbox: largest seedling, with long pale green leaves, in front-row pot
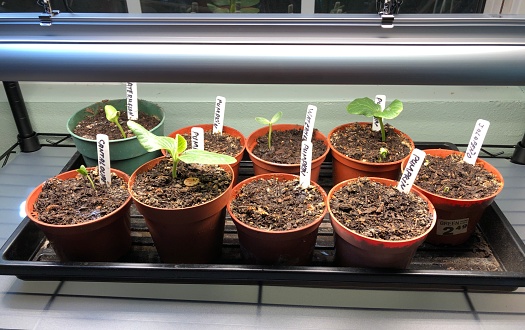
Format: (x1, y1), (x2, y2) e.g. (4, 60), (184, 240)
(128, 120), (236, 178)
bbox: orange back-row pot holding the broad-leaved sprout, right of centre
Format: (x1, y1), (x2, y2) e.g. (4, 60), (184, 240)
(328, 122), (415, 184)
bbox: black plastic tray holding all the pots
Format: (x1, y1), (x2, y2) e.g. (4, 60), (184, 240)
(0, 143), (525, 291)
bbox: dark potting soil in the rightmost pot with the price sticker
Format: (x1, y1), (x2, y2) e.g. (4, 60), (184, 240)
(415, 154), (501, 199)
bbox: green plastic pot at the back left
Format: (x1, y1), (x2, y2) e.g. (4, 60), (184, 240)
(67, 99), (164, 175)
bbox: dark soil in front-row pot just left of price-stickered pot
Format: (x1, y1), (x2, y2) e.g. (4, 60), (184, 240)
(329, 178), (432, 241)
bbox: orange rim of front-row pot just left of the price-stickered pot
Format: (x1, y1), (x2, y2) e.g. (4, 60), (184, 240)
(328, 177), (437, 245)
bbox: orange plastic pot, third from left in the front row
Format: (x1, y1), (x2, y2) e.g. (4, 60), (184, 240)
(227, 173), (327, 265)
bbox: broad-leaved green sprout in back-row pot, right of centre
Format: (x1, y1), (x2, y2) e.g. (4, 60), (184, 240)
(346, 97), (403, 142)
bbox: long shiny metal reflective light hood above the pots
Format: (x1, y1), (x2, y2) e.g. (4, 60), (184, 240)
(0, 13), (525, 86)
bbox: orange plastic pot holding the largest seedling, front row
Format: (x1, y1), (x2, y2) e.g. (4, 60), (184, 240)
(128, 157), (233, 264)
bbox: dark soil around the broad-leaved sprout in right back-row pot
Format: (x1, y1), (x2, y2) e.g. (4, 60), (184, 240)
(330, 123), (411, 163)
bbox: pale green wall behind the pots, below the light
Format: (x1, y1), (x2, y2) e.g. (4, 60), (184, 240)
(0, 82), (525, 159)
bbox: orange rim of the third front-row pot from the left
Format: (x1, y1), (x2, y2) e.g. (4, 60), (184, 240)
(226, 173), (328, 235)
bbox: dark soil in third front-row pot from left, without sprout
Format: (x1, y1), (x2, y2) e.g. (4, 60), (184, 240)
(231, 179), (325, 231)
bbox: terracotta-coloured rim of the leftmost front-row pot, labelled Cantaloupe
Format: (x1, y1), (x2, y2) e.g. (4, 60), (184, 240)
(25, 167), (131, 228)
